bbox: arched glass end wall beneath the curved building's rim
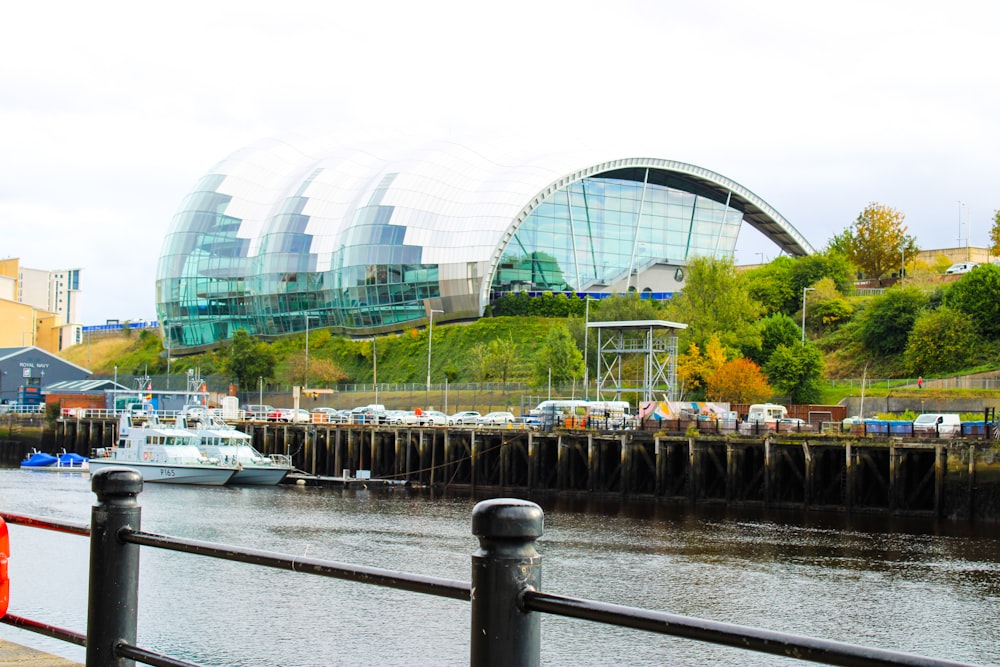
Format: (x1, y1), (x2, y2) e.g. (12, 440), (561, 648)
(493, 173), (743, 294)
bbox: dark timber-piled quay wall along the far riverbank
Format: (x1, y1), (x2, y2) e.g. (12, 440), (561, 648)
(48, 418), (1000, 521)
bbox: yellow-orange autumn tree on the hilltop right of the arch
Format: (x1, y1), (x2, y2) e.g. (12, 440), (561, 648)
(829, 202), (920, 278)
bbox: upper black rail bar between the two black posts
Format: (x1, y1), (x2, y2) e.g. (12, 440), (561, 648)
(118, 529), (472, 602)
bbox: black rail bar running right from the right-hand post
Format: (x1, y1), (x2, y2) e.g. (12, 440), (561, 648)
(521, 590), (973, 667)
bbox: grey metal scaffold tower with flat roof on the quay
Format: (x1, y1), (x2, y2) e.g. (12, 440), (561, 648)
(587, 320), (687, 403)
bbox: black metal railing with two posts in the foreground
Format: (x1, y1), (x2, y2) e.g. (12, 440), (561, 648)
(0, 468), (980, 667)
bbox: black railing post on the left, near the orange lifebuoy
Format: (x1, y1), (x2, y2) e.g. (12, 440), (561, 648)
(87, 468), (142, 667)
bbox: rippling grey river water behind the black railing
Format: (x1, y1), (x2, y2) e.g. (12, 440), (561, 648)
(0, 469), (1000, 666)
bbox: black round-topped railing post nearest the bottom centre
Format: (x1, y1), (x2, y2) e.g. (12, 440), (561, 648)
(470, 498), (544, 667)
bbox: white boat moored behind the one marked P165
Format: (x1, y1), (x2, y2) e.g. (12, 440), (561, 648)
(177, 406), (294, 486)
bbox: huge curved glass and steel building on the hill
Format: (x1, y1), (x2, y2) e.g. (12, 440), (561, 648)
(156, 140), (812, 351)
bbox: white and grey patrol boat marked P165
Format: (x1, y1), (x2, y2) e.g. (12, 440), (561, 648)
(90, 412), (238, 486)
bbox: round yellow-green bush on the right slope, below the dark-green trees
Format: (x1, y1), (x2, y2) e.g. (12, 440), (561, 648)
(903, 307), (979, 375)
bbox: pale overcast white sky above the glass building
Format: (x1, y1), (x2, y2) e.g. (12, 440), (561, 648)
(0, 0), (1000, 325)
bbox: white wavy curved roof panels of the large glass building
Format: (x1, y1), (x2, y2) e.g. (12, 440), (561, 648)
(174, 140), (813, 271)
